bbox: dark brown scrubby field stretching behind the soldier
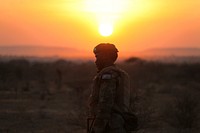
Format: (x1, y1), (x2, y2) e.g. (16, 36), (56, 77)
(0, 58), (200, 133)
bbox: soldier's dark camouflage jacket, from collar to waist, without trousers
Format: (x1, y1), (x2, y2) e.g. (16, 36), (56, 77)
(89, 66), (130, 120)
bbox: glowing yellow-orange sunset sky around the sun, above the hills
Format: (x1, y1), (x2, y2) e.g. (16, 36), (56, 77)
(0, 0), (200, 57)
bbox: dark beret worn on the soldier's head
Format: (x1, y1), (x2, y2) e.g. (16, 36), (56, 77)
(93, 43), (119, 54)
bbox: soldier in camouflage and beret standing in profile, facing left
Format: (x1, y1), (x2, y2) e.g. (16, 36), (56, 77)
(88, 43), (130, 133)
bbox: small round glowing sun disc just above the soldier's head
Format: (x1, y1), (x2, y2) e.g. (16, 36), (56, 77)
(99, 23), (113, 37)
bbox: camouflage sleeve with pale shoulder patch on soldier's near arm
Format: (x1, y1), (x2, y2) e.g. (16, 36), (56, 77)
(96, 74), (117, 120)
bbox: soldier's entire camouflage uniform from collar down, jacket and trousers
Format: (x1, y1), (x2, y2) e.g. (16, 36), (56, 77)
(89, 65), (130, 133)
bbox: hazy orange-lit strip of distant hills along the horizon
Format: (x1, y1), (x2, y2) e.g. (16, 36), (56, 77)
(0, 45), (200, 60)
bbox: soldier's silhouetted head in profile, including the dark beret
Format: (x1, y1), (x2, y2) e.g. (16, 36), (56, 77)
(93, 43), (118, 70)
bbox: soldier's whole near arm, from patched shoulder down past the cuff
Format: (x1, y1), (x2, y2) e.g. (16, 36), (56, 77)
(93, 74), (117, 133)
